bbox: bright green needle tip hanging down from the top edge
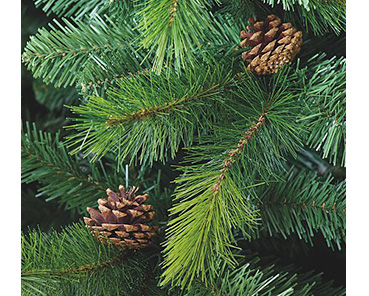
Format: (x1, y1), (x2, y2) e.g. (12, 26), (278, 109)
(137, 0), (211, 73)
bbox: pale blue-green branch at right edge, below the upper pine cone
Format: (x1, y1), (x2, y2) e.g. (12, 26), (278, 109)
(302, 54), (346, 166)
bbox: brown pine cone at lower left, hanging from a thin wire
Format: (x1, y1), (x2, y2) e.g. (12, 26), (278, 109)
(83, 185), (157, 249)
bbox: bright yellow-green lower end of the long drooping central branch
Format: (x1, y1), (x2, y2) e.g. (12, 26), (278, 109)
(161, 171), (257, 288)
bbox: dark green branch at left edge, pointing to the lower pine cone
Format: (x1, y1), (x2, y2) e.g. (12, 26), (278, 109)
(22, 122), (125, 212)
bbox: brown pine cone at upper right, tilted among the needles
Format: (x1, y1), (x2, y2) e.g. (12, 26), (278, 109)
(240, 14), (302, 75)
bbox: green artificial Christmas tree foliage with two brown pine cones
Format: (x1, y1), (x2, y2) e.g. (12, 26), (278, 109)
(22, 0), (346, 296)
